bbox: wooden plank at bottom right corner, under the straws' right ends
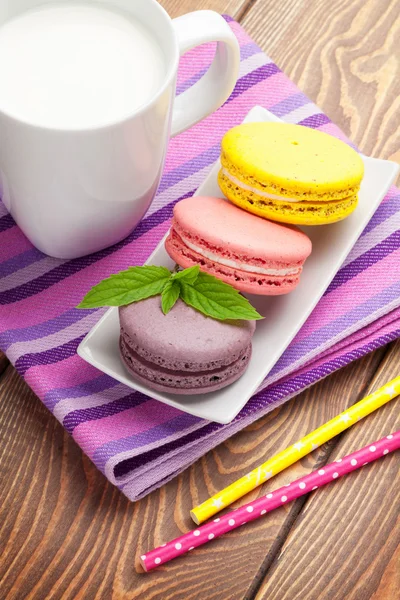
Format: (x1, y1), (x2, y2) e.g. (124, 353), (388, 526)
(257, 342), (400, 600)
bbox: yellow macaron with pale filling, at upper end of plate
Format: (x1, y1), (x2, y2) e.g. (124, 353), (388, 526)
(218, 122), (364, 225)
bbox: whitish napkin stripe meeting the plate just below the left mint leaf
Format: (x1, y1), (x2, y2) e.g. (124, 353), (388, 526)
(7, 309), (107, 362)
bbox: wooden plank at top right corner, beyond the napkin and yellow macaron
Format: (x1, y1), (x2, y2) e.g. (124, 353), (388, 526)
(242, 0), (400, 166)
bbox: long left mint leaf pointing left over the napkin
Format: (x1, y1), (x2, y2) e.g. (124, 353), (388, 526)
(78, 266), (171, 308)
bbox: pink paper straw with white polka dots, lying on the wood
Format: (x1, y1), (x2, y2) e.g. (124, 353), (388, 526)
(141, 431), (400, 571)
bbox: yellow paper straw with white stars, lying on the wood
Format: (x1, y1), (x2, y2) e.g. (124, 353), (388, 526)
(190, 377), (400, 525)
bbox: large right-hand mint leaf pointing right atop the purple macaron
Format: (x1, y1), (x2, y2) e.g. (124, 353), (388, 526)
(180, 271), (263, 321)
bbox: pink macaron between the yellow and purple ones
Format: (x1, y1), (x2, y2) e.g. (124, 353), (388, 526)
(165, 196), (312, 296)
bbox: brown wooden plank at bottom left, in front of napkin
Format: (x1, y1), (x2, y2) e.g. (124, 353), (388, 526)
(0, 350), (384, 600)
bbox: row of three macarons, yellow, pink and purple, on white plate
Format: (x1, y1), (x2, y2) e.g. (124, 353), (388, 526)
(119, 123), (364, 394)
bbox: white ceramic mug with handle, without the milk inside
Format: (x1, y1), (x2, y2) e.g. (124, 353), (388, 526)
(0, 0), (240, 259)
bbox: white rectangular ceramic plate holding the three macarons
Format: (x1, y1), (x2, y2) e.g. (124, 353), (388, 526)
(78, 106), (398, 423)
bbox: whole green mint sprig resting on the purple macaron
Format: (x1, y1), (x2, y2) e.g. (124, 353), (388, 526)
(78, 265), (263, 321)
